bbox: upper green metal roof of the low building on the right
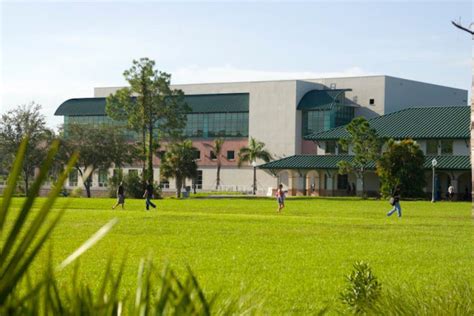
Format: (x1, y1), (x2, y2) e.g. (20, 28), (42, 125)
(304, 106), (471, 141)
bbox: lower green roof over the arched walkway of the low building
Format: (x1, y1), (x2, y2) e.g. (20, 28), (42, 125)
(259, 155), (471, 170)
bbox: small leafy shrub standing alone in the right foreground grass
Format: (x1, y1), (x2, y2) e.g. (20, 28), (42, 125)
(341, 261), (382, 315)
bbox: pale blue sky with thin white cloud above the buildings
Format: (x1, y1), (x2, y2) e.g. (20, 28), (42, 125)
(0, 0), (474, 127)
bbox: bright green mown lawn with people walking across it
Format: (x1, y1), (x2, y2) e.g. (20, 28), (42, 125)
(4, 198), (474, 314)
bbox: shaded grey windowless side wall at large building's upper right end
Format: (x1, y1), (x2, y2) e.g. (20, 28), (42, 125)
(384, 76), (467, 113)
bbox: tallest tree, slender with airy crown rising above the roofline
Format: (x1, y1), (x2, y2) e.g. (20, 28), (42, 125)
(106, 58), (189, 182)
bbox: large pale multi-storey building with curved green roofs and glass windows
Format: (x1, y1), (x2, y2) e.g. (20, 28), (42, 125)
(55, 76), (467, 194)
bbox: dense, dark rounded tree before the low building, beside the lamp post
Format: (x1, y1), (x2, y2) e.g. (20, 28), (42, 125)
(377, 139), (426, 197)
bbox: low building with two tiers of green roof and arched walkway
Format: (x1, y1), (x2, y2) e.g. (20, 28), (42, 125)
(260, 106), (471, 199)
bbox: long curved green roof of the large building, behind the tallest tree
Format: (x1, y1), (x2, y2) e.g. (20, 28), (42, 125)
(54, 93), (249, 116)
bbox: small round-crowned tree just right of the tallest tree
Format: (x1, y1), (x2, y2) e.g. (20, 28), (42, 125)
(160, 140), (197, 198)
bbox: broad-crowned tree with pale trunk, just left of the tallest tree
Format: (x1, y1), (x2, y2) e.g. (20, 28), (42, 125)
(61, 124), (136, 197)
